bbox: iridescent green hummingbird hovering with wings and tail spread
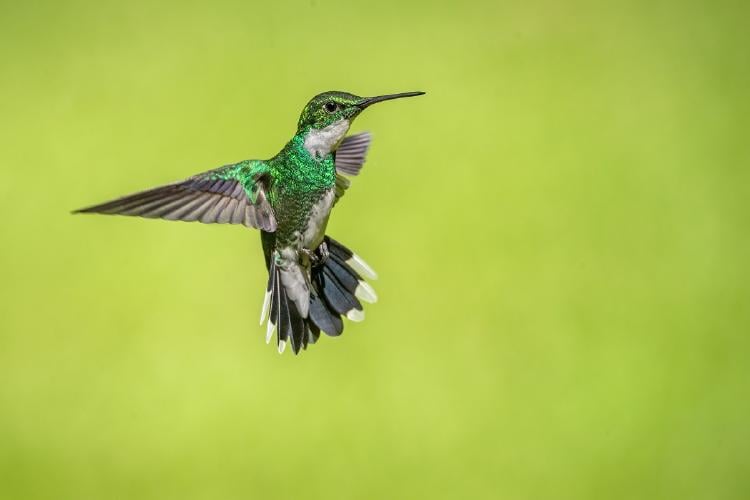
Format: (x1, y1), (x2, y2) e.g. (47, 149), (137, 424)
(78, 91), (424, 354)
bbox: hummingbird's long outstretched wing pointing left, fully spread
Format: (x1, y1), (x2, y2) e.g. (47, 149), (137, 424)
(74, 160), (276, 231)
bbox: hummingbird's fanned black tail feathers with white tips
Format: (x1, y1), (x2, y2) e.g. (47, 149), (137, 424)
(260, 236), (378, 354)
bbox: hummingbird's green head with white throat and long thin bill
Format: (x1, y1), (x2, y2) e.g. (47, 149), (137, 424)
(297, 91), (424, 156)
